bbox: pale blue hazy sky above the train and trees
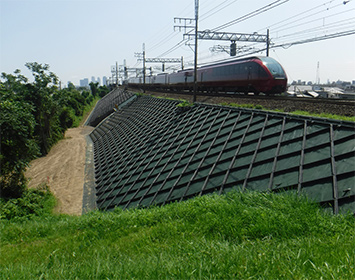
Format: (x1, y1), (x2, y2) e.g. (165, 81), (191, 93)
(0, 0), (355, 85)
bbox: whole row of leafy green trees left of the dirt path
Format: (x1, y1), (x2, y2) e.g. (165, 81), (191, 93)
(0, 62), (109, 199)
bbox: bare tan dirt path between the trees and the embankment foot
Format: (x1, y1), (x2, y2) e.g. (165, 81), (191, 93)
(26, 126), (93, 215)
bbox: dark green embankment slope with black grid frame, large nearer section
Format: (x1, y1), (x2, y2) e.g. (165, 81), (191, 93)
(90, 96), (355, 213)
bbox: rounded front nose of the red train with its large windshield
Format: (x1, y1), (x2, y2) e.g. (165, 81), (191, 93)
(256, 57), (287, 94)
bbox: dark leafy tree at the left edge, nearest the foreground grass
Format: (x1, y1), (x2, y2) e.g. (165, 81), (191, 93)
(0, 97), (39, 198)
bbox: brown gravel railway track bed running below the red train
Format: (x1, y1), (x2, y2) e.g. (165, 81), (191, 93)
(131, 89), (355, 117)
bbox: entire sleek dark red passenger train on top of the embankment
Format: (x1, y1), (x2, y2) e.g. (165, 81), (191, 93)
(125, 56), (287, 94)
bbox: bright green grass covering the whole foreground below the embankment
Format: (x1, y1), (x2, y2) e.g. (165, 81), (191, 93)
(0, 192), (355, 279)
